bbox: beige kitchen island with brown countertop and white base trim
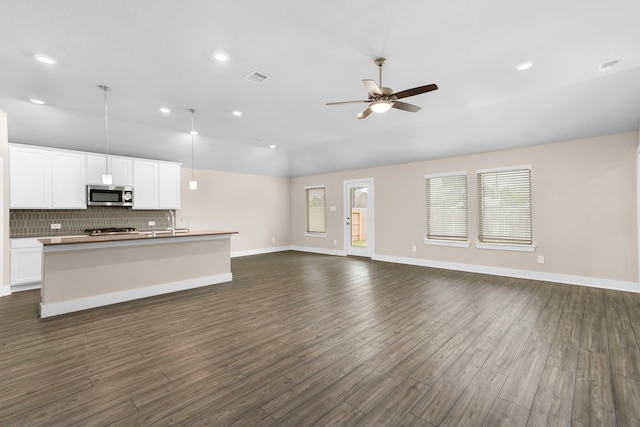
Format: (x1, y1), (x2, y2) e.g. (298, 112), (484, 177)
(40, 231), (236, 318)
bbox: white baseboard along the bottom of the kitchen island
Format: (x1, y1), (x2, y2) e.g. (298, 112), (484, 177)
(40, 273), (233, 318)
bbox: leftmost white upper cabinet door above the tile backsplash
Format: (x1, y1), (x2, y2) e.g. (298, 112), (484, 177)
(9, 146), (51, 209)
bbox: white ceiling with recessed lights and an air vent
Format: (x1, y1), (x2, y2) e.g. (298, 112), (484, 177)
(0, 0), (640, 176)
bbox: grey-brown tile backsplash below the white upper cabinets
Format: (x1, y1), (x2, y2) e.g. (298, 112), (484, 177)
(9, 206), (175, 237)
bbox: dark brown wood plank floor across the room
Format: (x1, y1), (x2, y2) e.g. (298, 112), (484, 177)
(0, 252), (640, 427)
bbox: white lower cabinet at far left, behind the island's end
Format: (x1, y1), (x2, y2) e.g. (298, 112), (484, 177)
(10, 238), (42, 291)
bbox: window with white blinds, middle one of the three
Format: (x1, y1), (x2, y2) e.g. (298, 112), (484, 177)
(425, 172), (467, 241)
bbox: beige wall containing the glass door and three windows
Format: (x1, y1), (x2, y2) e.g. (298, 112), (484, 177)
(291, 132), (640, 291)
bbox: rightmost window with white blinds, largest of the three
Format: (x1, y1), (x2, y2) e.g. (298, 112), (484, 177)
(477, 166), (533, 245)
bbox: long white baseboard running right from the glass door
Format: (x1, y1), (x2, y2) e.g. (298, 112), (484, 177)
(371, 255), (640, 293)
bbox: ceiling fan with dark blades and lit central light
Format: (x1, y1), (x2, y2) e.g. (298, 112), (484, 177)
(327, 58), (438, 119)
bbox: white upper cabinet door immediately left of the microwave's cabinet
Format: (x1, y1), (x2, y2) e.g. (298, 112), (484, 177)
(51, 151), (87, 209)
